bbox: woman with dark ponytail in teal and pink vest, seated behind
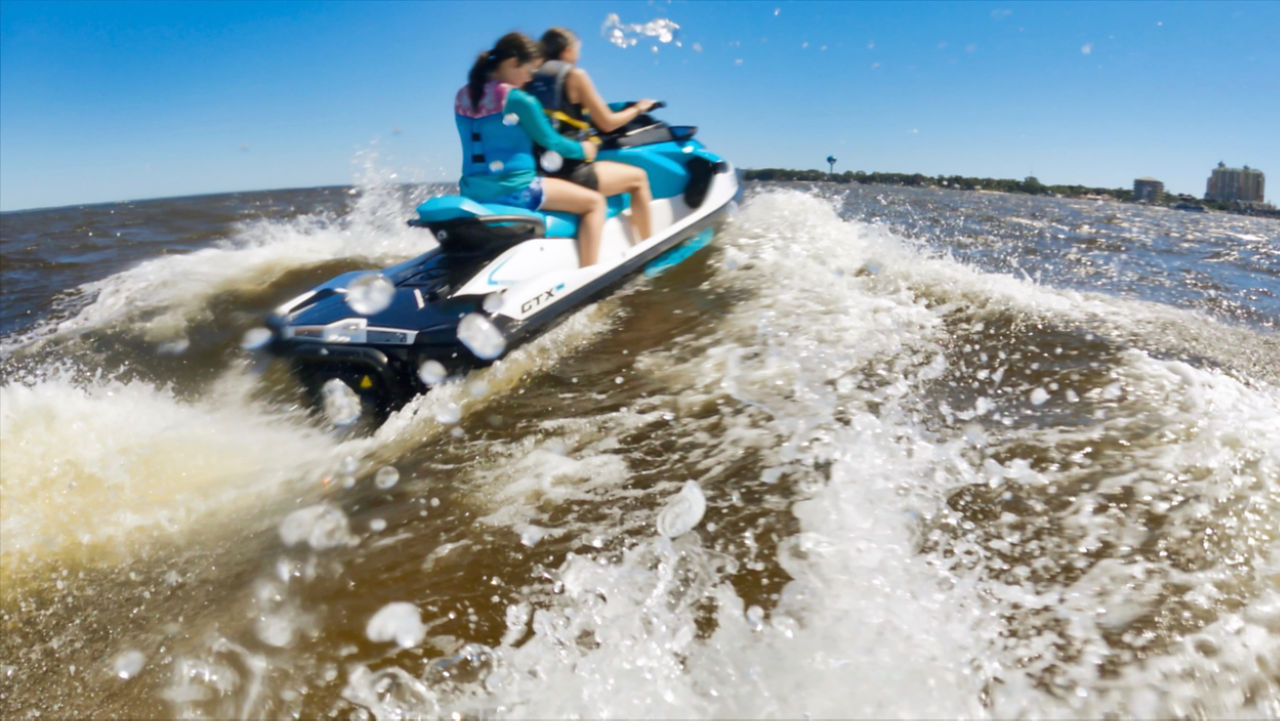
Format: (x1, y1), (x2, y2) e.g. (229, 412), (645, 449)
(453, 32), (605, 268)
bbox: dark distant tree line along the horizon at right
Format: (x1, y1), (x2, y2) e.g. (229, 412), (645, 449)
(745, 168), (1280, 216)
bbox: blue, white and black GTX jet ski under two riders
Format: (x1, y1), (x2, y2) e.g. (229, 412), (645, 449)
(253, 104), (742, 425)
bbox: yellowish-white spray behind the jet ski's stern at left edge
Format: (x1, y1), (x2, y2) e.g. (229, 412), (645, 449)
(0, 373), (333, 583)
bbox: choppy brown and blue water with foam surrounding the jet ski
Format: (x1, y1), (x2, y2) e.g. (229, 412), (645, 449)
(0, 184), (1280, 718)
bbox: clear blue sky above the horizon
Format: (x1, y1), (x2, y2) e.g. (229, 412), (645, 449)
(0, 0), (1280, 210)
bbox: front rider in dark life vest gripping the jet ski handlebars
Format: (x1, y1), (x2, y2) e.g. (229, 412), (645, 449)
(525, 28), (654, 241)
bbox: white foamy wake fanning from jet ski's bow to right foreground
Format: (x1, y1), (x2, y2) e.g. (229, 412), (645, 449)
(442, 193), (1280, 717)
